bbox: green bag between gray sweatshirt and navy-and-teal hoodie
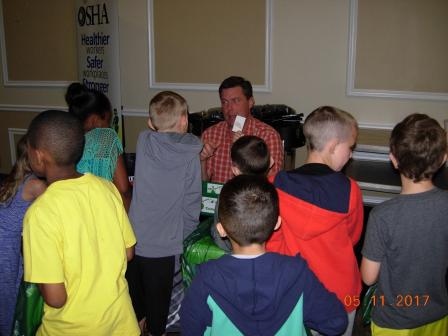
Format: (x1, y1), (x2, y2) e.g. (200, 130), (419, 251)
(182, 217), (225, 288)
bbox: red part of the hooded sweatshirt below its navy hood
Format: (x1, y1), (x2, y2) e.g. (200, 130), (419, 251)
(266, 172), (364, 312)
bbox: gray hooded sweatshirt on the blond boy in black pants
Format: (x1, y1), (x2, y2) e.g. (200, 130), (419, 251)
(129, 130), (202, 258)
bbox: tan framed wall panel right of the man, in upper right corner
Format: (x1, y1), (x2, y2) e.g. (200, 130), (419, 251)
(354, 0), (448, 93)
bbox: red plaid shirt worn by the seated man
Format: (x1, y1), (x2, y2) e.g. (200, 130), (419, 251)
(202, 117), (284, 183)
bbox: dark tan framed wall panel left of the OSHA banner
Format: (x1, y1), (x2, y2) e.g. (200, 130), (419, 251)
(2, 0), (78, 81)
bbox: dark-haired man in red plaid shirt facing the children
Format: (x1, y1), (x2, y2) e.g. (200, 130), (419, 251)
(201, 76), (283, 183)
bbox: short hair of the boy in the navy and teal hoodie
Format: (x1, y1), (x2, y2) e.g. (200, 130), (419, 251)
(218, 175), (279, 246)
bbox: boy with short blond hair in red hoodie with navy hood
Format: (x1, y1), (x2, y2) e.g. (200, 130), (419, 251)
(266, 106), (363, 335)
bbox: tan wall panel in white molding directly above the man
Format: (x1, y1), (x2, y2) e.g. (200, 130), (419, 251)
(152, 0), (267, 85)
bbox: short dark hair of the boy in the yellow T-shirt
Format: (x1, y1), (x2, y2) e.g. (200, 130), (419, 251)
(28, 110), (84, 166)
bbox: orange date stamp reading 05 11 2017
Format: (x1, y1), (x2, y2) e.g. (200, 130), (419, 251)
(344, 294), (429, 308)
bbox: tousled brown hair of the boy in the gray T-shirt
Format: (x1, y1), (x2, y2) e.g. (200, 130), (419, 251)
(389, 113), (447, 182)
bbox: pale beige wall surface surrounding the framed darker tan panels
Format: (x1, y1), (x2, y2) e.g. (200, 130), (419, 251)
(0, 0), (448, 172)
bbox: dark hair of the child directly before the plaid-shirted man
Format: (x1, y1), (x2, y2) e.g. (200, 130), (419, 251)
(230, 135), (271, 176)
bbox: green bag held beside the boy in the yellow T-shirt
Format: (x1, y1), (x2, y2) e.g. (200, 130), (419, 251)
(12, 281), (44, 336)
